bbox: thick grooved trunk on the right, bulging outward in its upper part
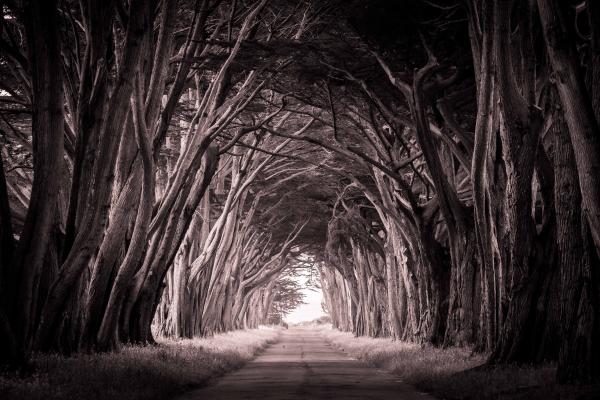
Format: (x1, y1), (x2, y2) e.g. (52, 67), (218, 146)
(490, 1), (541, 362)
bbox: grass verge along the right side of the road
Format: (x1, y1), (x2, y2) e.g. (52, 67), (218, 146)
(321, 329), (600, 400)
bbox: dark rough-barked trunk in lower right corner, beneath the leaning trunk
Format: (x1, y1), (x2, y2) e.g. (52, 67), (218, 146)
(554, 108), (600, 383)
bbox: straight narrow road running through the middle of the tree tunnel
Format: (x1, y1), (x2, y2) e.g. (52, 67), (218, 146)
(179, 328), (434, 400)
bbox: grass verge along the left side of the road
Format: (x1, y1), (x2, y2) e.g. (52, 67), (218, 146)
(0, 328), (279, 400)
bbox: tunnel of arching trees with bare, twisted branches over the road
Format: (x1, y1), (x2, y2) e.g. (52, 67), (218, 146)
(0, 0), (600, 382)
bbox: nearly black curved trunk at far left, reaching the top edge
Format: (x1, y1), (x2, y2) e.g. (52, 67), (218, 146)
(9, 0), (64, 360)
